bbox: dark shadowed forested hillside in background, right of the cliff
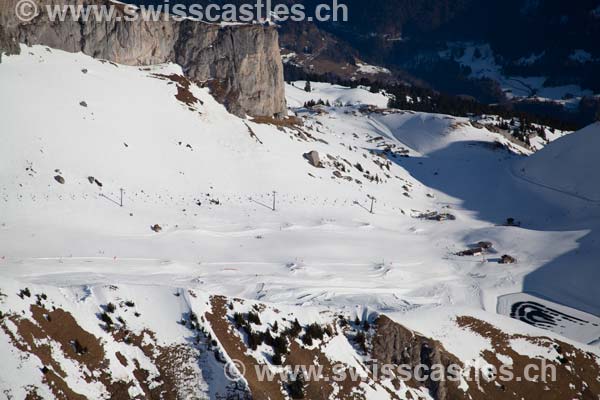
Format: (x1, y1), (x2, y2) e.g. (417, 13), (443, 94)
(126, 0), (600, 124)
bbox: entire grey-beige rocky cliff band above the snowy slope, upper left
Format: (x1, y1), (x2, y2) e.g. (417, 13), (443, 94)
(0, 0), (286, 116)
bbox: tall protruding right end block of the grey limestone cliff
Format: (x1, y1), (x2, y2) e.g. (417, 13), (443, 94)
(175, 20), (286, 116)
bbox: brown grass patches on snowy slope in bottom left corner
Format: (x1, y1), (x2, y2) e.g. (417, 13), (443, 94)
(0, 305), (197, 400)
